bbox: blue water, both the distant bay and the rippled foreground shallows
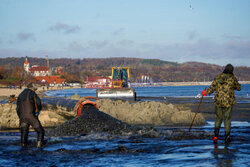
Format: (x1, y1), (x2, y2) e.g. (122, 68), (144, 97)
(0, 85), (250, 167)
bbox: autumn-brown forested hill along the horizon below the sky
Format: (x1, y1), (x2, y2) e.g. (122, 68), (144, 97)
(0, 57), (250, 82)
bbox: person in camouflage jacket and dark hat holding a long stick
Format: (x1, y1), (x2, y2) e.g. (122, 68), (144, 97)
(202, 64), (241, 143)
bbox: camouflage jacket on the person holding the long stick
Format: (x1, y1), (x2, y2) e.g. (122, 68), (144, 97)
(206, 73), (241, 107)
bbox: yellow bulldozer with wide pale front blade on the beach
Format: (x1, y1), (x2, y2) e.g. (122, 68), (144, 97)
(96, 67), (136, 100)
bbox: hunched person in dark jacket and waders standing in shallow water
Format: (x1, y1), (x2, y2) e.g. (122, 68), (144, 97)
(16, 83), (45, 147)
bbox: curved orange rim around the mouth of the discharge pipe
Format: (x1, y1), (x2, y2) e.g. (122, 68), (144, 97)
(74, 96), (100, 116)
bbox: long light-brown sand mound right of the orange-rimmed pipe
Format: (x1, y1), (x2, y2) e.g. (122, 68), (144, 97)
(98, 99), (205, 126)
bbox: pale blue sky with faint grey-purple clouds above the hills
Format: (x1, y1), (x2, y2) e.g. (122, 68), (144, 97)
(0, 0), (250, 67)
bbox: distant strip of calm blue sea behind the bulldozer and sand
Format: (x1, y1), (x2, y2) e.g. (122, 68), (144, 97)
(46, 84), (250, 103)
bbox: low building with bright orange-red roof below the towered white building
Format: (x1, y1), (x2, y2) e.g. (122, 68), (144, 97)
(35, 75), (65, 86)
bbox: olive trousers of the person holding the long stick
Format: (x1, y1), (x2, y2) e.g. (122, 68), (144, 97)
(214, 105), (233, 138)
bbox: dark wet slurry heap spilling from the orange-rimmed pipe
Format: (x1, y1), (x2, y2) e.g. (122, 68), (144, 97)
(46, 105), (211, 140)
